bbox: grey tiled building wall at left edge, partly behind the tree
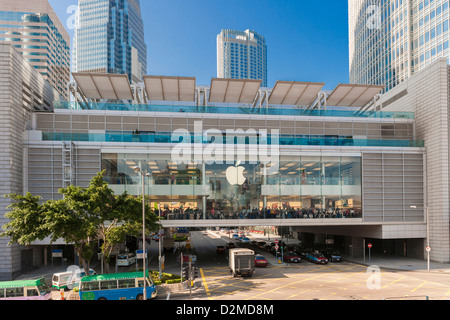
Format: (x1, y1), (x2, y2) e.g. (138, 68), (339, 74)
(0, 44), (60, 279)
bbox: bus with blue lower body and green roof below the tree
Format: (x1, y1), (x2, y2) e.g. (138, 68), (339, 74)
(79, 271), (157, 300)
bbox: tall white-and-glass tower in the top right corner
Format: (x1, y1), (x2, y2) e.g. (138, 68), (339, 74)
(348, 0), (450, 91)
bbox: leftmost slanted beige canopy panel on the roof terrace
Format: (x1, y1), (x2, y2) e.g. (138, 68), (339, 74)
(72, 73), (133, 100)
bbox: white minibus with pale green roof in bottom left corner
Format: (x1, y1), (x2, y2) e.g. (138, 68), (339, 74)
(0, 278), (52, 300)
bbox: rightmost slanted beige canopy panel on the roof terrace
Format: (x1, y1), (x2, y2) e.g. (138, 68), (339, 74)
(327, 84), (384, 108)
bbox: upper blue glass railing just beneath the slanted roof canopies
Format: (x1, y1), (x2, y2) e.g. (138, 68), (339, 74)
(54, 101), (415, 119)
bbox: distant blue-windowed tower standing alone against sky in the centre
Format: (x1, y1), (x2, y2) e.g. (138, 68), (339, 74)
(217, 30), (267, 87)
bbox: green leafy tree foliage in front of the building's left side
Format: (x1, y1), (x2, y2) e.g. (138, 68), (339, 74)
(1, 172), (159, 271)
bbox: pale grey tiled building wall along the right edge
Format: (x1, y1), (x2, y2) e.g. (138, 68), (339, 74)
(377, 59), (450, 262)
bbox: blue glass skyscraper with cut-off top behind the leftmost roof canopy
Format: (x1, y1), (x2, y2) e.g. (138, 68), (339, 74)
(73, 0), (147, 82)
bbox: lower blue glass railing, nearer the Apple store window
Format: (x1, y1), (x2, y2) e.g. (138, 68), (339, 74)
(42, 132), (424, 148)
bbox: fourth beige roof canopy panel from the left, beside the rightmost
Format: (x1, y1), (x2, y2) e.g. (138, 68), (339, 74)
(269, 81), (325, 106)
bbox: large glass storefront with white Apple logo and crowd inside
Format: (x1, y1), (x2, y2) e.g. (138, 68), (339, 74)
(102, 154), (362, 219)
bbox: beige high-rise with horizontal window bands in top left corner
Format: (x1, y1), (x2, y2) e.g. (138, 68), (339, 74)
(0, 0), (70, 100)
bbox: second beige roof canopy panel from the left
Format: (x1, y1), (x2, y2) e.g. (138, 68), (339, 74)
(144, 76), (195, 102)
